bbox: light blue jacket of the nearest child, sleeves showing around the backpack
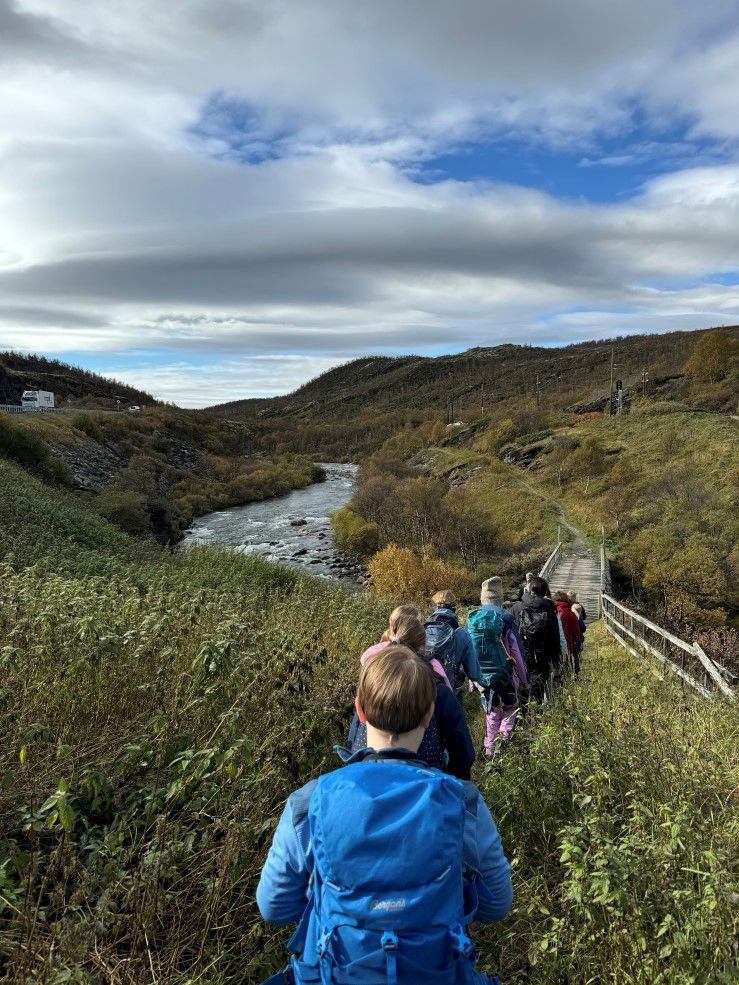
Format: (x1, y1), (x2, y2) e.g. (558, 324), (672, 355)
(257, 750), (513, 936)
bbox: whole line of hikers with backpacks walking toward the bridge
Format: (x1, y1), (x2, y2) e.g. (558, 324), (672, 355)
(257, 573), (586, 985)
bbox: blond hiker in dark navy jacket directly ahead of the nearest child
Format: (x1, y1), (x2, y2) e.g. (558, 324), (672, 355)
(346, 615), (475, 780)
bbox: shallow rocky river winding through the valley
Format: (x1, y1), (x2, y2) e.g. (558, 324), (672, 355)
(182, 462), (365, 588)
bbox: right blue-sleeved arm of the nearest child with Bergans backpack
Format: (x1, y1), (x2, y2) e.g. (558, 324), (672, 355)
(464, 792), (513, 923)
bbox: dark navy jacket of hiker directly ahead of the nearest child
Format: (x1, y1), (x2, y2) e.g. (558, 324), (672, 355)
(347, 681), (475, 780)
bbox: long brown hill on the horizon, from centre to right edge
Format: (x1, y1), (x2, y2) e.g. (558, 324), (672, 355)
(211, 327), (739, 460)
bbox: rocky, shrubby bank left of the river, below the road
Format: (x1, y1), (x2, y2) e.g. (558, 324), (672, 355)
(0, 407), (323, 543)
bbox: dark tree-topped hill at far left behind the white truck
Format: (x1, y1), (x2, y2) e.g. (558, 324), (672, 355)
(0, 352), (158, 409)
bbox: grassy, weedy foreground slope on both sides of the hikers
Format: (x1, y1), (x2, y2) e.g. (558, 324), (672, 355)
(0, 461), (739, 985)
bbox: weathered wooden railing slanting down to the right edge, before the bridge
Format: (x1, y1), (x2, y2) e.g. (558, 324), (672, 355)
(601, 592), (734, 699)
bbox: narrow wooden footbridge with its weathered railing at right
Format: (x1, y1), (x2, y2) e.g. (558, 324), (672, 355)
(539, 524), (739, 700)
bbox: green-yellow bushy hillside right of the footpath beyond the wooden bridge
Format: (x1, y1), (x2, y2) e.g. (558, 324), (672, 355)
(516, 404), (739, 628)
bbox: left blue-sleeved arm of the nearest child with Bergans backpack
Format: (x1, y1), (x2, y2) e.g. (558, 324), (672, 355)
(257, 791), (311, 926)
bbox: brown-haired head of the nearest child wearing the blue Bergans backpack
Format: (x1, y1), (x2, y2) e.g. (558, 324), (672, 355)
(355, 645), (436, 752)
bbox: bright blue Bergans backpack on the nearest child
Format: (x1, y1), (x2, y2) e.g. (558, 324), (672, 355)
(288, 758), (478, 985)
